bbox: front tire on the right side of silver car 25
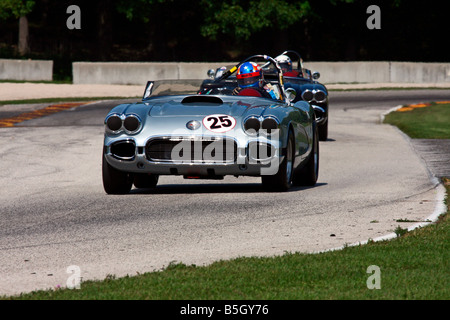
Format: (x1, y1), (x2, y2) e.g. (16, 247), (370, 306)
(261, 131), (295, 191)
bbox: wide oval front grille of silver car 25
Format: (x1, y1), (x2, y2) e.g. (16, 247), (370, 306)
(145, 138), (237, 163)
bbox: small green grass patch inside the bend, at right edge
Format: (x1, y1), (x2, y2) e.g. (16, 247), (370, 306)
(384, 104), (450, 139)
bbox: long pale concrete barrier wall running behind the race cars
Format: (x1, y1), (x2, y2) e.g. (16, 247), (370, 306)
(73, 61), (450, 85)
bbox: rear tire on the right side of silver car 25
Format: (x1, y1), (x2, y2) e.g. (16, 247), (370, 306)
(293, 125), (319, 186)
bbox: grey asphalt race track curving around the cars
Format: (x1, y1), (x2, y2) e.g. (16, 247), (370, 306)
(0, 90), (450, 295)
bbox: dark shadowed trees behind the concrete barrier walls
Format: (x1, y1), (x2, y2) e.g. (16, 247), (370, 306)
(0, 0), (449, 77)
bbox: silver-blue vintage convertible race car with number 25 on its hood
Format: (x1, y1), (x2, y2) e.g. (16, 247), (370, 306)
(102, 55), (319, 194)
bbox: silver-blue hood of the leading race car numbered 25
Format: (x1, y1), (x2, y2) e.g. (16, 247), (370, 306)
(110, 95), (285, 138)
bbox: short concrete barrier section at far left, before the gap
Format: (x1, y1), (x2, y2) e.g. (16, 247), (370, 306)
(0, 59), (53, 81)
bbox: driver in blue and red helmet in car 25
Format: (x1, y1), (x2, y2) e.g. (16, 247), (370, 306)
(233, 62), (280, 100)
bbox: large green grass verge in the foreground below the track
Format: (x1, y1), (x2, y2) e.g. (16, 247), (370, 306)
(2, 99), (450, 300)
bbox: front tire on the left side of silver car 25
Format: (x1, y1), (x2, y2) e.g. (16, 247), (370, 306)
(102, 155), (133, 194)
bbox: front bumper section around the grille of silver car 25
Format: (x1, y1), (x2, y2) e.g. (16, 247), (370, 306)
(104, 139), (284, 178)
